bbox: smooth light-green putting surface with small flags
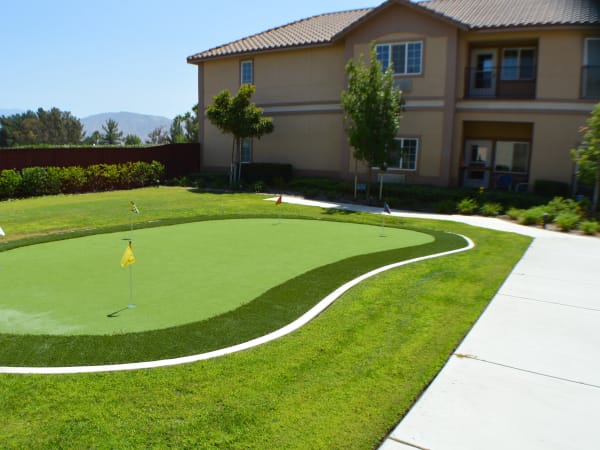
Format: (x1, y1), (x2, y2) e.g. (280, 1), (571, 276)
(0, 219), (434, 335)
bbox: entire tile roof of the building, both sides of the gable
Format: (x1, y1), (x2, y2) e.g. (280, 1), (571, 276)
(187, 0), (600, 64)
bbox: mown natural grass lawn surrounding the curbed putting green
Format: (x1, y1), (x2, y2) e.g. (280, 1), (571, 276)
(0, 188), (529, 449)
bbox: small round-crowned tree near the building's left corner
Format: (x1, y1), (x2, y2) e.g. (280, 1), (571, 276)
(206, 84), (274, 185)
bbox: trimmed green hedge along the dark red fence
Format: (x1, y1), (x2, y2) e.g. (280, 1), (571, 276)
(0, 161), (165, 200)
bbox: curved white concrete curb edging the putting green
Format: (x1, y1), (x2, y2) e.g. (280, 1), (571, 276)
(0, 235), (475, 375)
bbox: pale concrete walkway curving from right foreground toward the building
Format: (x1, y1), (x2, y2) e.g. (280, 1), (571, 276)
(282, 197), (600, 450)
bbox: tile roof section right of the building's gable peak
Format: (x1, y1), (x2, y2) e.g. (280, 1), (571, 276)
(419, 0), (600, 29)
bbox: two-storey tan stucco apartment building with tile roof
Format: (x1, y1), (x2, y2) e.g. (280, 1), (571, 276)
(188, 0), (600, 189)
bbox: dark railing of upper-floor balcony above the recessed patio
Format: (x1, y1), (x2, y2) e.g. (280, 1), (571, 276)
(465, 66), (536, 99)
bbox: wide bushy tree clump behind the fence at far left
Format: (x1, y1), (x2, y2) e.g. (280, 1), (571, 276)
(0, 108), (83, 147)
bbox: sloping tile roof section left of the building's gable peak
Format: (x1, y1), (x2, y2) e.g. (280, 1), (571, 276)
(188, 8), (372, 63)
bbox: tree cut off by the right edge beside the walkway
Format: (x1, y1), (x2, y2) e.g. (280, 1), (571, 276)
(571, 103), (600, 215)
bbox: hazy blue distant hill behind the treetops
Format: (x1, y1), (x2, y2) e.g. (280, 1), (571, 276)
(80, 112), (171, 142)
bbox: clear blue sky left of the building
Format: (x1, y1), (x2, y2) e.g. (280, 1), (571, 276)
(0, 0), (383, 118)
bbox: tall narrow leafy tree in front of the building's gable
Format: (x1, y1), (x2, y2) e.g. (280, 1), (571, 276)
(342, 45), (404, 196)
